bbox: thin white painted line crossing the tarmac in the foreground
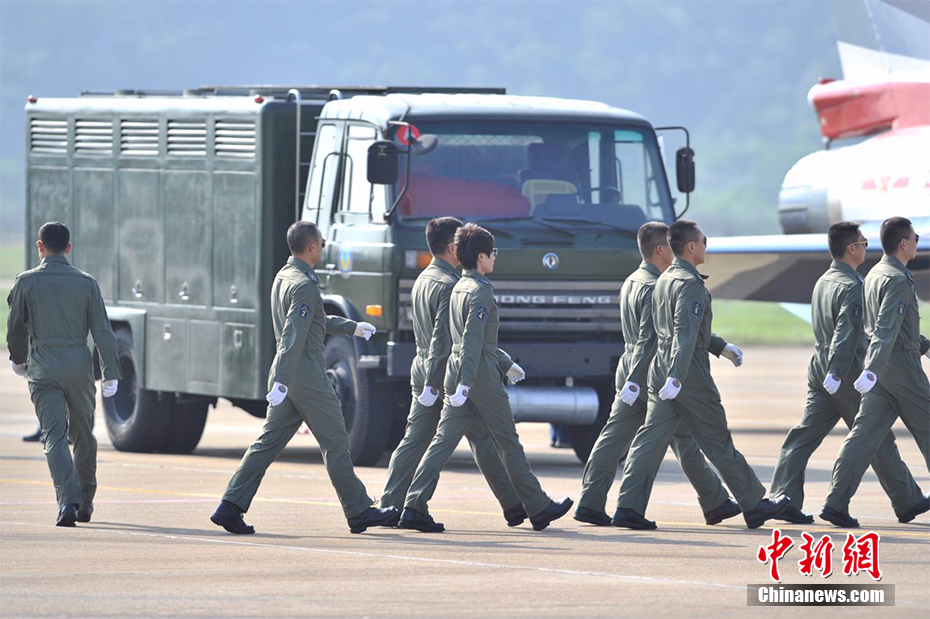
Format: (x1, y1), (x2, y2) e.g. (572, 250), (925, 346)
(0, 520), (746, 591)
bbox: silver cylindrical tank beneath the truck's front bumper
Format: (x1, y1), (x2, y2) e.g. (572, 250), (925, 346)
(507, 386), (600, 426)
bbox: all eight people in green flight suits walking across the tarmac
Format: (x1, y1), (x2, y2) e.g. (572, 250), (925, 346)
(7, 217), (930, 534)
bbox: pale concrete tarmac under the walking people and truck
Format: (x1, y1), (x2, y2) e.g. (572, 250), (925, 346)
(0, 348), (930, 617)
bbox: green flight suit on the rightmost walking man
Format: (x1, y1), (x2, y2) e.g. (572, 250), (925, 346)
(824, 255), (930, 514)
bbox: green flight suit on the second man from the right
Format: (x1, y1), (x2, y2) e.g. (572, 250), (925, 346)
(769, 261), (923, 513)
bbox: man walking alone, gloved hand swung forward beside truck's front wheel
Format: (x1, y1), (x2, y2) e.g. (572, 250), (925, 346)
(210, 221), (397, 534)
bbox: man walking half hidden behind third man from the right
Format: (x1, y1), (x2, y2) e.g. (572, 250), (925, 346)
(574, 221), (742, 526)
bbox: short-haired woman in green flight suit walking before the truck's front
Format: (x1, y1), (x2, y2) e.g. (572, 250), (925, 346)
(399, 224), (572, 532)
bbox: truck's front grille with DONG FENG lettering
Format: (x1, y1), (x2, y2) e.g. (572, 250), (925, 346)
(398, 279), (621, 339)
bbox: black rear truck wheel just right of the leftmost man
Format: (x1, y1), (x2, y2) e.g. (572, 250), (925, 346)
(103, 327), (174, 452)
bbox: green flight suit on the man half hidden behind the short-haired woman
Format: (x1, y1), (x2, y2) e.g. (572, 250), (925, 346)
(381, 258), (520, 511)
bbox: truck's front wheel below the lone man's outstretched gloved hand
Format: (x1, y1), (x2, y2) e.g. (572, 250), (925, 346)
(324, 335), (393, 466)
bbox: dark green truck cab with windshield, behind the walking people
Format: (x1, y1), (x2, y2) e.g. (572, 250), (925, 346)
(302, 93), (674, 459)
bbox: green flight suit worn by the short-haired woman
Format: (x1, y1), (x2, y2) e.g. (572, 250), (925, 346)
(404, 269), (551, 516)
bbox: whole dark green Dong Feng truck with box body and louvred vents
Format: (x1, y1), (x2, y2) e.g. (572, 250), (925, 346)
(26, 86), (694, 465)
